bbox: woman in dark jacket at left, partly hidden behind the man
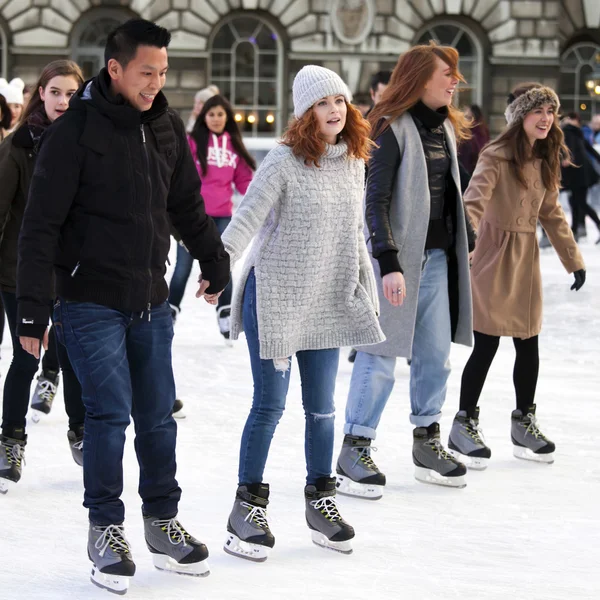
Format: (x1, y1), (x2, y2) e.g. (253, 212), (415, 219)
(0, 60), (85, 491)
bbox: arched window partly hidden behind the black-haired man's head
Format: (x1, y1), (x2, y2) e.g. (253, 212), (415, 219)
(71, 9), (132, 79)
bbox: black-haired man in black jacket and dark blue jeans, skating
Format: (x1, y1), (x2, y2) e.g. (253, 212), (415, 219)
(17, 20), (229, 593)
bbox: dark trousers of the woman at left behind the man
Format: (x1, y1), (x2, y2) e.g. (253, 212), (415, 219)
(2, 292), (85, 437)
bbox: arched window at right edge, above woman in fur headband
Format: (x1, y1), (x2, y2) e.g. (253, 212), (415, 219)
(558, 42), (600, 121)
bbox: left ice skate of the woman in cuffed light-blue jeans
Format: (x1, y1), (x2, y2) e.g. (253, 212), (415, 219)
(336, 435), (385, 500)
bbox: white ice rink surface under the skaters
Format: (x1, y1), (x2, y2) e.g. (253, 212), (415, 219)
(0, 236), (600, 600)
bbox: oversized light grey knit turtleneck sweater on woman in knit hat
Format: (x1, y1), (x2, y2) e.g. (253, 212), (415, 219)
(223, 142), (385, 359)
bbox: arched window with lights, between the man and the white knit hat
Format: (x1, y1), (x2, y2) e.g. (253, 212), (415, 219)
(209, 15), (283, 136)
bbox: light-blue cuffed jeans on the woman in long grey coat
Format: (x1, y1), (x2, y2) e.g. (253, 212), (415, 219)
(344, 250), (452, 439)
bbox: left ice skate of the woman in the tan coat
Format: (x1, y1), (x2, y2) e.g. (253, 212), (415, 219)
(448, 407), (492, 471)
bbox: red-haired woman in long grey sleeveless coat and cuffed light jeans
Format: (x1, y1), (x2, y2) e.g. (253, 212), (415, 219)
(337, 42), (474, 499)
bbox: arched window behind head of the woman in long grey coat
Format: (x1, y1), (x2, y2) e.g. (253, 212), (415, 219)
(417, 21), (483, 107)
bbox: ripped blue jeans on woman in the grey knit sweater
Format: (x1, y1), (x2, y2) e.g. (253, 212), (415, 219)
(238, 270), (340, 485)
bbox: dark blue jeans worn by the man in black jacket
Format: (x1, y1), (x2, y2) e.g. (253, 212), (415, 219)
(54, 299), (181, 525)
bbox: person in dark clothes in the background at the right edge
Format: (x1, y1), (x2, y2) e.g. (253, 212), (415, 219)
(561, 112), (600, 244)
